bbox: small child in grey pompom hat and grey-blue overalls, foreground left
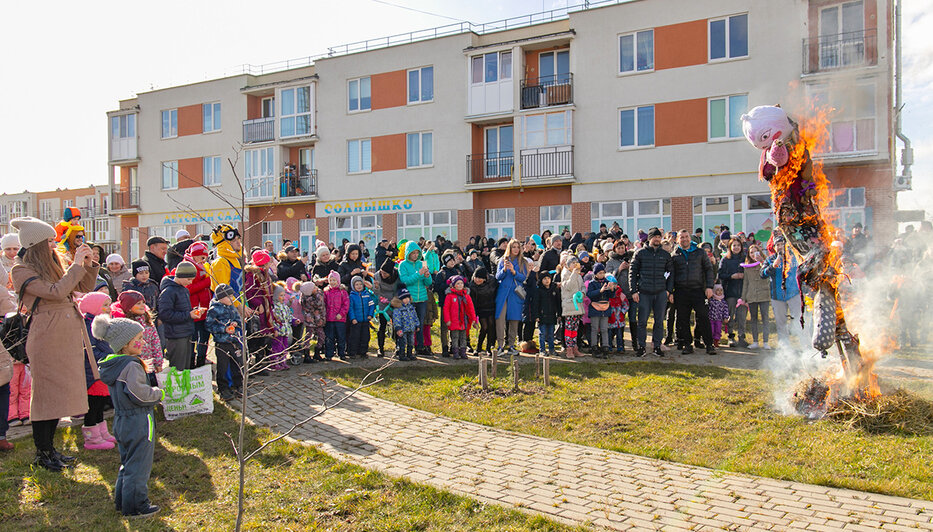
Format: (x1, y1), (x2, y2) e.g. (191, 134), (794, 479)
(91, 316), (163, 517)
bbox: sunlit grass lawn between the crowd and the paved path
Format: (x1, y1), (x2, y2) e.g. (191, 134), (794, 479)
(331, 362), (933, 500)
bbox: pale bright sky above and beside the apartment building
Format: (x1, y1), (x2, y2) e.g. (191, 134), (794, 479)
(0, 0), (933, 217)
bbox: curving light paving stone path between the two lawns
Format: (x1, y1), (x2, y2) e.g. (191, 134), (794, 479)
(244, 369), (933, 531)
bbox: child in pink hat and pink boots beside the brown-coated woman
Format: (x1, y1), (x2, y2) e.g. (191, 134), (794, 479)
(78, 292), (117, 450)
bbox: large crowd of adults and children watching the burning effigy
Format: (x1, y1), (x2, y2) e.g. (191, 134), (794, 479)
(0, 212), (933, 515)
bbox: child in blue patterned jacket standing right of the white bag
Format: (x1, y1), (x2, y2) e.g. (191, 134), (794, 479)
(204, 283), (243, 401)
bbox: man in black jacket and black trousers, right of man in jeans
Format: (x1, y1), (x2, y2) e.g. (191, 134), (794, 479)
(669, 229), (716, 355)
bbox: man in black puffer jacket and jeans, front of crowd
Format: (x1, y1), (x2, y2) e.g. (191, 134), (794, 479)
(629, 227), (674, 357)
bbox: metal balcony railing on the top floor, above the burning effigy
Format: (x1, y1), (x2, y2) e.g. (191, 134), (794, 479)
(803, 28), (878, 74)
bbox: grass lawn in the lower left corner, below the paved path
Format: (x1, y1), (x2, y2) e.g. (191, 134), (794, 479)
(0, 404), (572, 531)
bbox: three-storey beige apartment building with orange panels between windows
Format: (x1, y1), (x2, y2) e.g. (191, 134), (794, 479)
(108, 0), (895, 255)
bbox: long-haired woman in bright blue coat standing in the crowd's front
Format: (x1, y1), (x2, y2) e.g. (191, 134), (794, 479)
(496, 238), (531, 351)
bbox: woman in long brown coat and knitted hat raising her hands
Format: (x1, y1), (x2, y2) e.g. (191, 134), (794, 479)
(10, 217), (100, 472)
